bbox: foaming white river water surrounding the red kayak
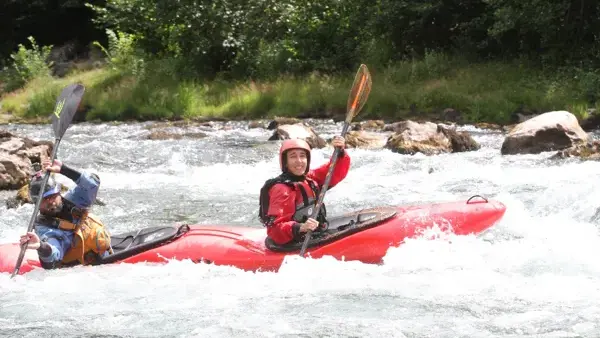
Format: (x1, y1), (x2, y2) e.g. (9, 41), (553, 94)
(0, 121), (600, 337)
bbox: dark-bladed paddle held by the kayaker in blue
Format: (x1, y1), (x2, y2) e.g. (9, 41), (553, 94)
(10, 84), (85, 278)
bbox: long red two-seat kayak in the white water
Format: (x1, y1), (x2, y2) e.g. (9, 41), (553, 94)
(0, 195), (506, 274)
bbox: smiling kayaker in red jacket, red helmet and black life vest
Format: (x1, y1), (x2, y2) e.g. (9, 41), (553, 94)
(259, 136), (350, 245)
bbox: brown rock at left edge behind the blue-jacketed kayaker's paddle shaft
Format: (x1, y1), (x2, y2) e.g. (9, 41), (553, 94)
(0, 130), (53, 190)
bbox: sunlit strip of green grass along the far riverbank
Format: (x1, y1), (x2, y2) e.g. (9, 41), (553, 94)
(0, 55), (600, 124)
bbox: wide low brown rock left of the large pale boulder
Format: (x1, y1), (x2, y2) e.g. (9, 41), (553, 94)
(385, 120), (480, 155)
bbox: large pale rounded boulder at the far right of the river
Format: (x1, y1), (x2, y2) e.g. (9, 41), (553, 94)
(501, 111), (588, 155)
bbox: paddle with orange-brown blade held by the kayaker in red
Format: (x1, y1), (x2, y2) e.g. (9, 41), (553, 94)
(300, 64), (371, 256)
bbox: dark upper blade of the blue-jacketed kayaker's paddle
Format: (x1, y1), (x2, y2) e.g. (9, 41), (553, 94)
(52, 84), (85, 139)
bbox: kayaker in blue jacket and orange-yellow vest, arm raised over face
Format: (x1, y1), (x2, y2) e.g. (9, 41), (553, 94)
(20, 160), (112, 269)
